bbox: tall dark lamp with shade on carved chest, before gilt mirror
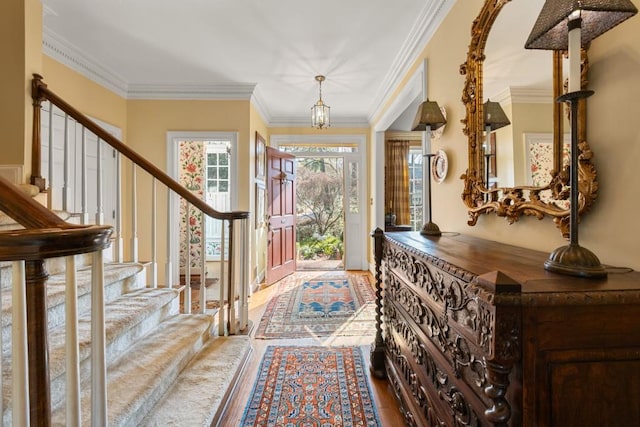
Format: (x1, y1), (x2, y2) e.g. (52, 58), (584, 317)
(525, 0), (638, 278)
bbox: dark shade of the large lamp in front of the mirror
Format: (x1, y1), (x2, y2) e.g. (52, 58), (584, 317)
(524, 0), (638, 50)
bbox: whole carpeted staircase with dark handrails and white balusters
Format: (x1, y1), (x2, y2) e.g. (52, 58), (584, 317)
(0, 75), (255, 427)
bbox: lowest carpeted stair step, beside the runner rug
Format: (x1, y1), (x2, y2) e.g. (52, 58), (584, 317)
(140, 335), (251, 427)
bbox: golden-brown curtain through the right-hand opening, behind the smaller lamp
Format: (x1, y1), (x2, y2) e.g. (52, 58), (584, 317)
(384, 140), (411, 224)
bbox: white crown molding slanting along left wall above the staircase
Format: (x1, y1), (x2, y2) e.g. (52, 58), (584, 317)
(42, 27), (128, 98)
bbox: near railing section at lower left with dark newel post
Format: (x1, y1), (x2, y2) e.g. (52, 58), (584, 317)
(0, 177), (112, 426)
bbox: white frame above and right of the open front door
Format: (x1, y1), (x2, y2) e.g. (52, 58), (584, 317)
(270, 134), (369, 270)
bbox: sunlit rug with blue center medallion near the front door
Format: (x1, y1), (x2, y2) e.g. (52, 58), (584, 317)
(255, 272), (376, 339)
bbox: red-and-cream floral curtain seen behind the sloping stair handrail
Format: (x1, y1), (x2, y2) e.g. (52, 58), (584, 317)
(179, 141), (205, 268)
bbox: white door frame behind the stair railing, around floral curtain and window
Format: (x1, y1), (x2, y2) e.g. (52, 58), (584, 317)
(166, 131), (239, 283)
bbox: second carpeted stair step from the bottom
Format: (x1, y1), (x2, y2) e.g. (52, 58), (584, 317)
(52, 314), (211, 426)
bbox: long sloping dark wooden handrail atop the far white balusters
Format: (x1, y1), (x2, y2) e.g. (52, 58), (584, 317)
(31, 74), (249, 220)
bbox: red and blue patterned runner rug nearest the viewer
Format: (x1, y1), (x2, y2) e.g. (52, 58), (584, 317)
(240, 346), (382, 427)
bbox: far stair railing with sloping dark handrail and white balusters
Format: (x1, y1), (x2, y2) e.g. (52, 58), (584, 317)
(31, 74), (249, 335)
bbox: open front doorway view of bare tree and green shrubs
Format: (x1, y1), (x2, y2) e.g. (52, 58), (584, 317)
(296, 157), (344, 270)
